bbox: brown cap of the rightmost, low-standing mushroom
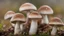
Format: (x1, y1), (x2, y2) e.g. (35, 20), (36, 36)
(49, 17), (64, 26)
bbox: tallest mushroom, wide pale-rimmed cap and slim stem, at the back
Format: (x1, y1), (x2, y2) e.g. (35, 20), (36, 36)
(19, 3), (37, 24)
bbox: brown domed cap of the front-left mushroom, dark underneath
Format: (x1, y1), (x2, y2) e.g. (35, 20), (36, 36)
(10, 13), (26, 24)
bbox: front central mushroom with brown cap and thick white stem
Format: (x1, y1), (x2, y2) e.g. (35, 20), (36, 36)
(28, 12), (42, 35)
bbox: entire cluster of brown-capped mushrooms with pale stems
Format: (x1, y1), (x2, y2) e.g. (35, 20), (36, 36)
(4, 3), (63, 36)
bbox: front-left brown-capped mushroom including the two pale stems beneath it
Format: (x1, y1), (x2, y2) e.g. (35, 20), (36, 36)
(10, 13), (26, 35)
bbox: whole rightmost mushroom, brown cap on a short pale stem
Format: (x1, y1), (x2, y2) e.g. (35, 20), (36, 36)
(49, 17), (63, 36)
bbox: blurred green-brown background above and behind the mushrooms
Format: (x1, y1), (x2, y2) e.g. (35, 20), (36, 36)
(0, 0), (64, 30)
